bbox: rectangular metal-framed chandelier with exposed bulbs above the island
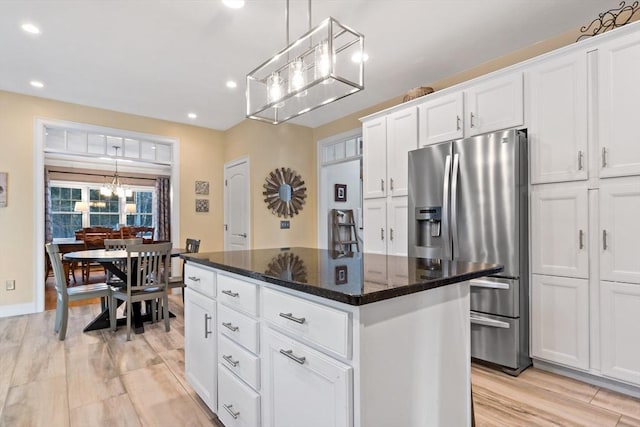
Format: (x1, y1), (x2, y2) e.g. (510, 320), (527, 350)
(246, 0), (364, 124)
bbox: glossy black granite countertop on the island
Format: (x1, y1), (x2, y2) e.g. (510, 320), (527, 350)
(180, 248), (502, 305)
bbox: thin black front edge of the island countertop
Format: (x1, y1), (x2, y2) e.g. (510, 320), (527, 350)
(180, 255), (503, 306)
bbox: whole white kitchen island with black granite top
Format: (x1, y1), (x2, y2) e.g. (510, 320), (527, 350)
(182, 248), (501, 427)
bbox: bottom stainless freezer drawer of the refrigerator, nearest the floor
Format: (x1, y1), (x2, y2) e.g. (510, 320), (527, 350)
(471, 311), (520, 369)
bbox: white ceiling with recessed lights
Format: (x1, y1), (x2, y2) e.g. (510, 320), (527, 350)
(0, 0), (618, 130)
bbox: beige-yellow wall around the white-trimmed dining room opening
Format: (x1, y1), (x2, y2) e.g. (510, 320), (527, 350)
(0, 91), (224, 306)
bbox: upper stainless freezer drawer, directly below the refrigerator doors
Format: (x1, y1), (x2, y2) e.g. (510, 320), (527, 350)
(470, 277), (520, 317)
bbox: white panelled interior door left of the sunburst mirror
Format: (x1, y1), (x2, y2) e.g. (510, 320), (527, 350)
(224, 157), (251, 251)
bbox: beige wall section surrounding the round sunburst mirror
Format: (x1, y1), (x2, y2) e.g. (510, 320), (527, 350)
(225, 120), (317, 249)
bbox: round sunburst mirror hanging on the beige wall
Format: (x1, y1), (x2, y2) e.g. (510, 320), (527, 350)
(262, 168), (307, 218)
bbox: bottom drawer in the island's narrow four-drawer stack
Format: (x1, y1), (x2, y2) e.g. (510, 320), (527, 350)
(218, 365), (260, 427)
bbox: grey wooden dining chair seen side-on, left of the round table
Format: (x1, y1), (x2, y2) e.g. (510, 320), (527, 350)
(46, 243), (111, 340)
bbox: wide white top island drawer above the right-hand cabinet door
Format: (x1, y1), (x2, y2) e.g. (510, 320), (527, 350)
(263, 289), (351, 358)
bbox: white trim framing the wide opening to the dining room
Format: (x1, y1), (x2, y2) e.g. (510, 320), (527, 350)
(31, 117), (180, 313)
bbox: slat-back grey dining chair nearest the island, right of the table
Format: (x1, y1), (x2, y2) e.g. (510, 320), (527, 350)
(109, 242), (171, 341)
